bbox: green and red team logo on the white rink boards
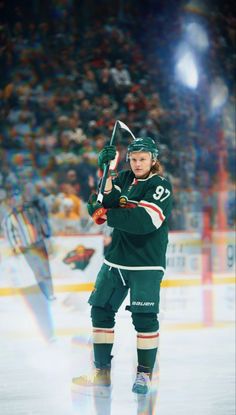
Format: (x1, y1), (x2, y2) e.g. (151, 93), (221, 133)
(63, 245), (95, 271)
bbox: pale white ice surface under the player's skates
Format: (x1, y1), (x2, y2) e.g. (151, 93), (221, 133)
(0, 285), (235, 415)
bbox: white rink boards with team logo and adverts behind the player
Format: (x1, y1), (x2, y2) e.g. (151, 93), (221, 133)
(0, 232), (235, 295)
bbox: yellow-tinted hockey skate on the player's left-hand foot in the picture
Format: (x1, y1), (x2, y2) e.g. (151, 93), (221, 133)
(72, 368), (111, 397)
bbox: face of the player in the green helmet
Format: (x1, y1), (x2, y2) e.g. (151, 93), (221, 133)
(129, 152), (155, 179)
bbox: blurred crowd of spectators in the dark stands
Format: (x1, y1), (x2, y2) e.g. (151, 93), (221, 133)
(0, 1), (235, 233)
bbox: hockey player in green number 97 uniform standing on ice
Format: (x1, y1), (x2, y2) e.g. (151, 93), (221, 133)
(73, 137), (172, 394)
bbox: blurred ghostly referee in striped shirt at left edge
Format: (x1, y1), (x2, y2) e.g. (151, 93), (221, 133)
(2, 185), (55, 301)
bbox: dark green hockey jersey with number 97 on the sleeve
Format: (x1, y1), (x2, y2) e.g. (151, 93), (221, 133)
(103, 170), (172, 271)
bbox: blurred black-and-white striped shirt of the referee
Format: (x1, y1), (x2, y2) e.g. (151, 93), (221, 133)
(2, 204), (50, 248)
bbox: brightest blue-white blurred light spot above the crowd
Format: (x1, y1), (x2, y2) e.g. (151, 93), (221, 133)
(175, 45), (198, 89)
